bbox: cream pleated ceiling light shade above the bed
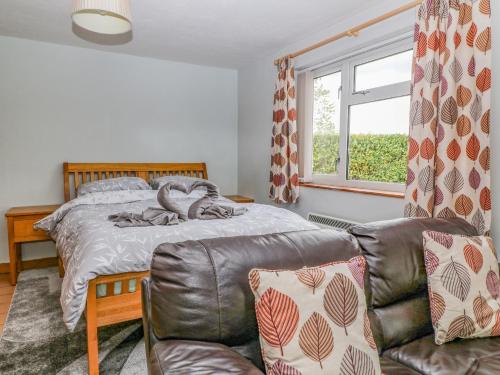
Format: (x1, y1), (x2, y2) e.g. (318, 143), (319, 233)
(72, 0), (132, 34)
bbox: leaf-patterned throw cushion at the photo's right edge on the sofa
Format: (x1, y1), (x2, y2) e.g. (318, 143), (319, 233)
(423, 231), (500, 345)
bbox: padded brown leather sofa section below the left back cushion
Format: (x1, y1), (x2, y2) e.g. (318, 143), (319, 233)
(148, 340), (263, 375)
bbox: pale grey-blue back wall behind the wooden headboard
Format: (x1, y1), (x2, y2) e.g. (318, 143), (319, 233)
(0, 37), (238, 263)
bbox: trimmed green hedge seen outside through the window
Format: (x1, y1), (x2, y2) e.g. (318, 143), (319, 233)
(313, 133), (408, 183)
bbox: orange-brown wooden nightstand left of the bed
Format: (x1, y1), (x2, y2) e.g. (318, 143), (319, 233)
(5, 205), (60, 285)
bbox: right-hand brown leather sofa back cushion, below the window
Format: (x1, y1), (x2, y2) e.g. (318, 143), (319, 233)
(350, 219), (477, 351)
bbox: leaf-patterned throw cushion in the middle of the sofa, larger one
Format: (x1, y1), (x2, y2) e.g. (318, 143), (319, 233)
(249, 256), (381, 375)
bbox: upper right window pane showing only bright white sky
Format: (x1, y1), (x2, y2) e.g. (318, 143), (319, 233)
(354, 51), (413, 91)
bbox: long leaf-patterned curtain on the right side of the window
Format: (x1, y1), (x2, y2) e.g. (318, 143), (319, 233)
(405, 0), (491, 233)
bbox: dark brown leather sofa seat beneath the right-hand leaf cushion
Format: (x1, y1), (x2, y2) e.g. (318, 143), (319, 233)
(383, 335), (500, 375)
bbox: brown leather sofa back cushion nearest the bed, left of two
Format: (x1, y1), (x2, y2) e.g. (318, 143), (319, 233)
(150, 230), (360, 368)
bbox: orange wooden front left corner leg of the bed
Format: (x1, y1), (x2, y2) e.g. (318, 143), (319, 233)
(87, 280), (99, 375)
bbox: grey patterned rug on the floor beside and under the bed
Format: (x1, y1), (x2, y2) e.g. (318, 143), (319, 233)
(0, 268), (147, 375)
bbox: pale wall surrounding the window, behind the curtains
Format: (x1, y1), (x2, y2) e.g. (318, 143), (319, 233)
(238, 0), (500, 236)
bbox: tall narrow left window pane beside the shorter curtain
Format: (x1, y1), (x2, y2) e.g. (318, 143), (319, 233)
(313, 72), (342, 175)
